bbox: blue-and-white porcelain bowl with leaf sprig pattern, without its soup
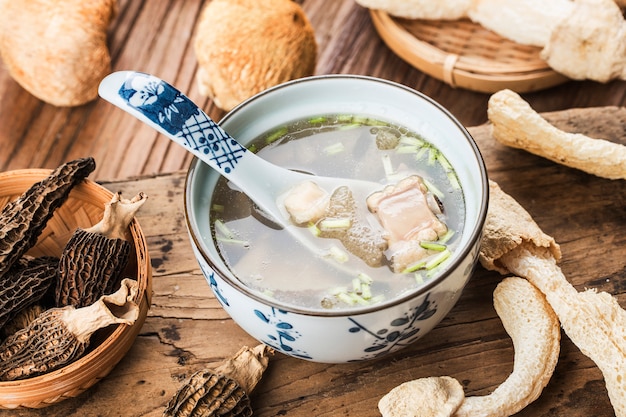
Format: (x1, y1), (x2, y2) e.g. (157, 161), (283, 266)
(185, 75), (488, 363)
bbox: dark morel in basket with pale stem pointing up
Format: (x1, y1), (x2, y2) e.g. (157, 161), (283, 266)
(55, 193), (148, 307)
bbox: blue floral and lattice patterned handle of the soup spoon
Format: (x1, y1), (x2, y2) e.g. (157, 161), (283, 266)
(98, 71), (247, 176)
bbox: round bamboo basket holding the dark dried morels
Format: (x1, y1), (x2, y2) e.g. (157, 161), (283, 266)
(0, 169), (152, 409)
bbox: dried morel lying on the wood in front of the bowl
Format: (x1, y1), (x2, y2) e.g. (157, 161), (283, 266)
(163, 344), (273, 417)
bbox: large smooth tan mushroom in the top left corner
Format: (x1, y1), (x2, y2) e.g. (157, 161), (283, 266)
(0, 0), (117, 106)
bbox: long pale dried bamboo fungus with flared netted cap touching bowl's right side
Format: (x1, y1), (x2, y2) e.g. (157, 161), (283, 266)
(479, 181), (626, 417)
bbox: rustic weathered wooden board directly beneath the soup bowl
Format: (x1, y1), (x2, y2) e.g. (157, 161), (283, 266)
(3, 107), (626, 417)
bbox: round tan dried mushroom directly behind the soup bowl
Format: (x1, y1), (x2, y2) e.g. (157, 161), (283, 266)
(194, 0), (317, 110)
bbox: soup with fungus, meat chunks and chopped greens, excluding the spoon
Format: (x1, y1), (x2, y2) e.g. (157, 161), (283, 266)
(210, 115), (465, 309)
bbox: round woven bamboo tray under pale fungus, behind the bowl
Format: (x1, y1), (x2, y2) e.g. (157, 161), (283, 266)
(370, 10), (568, 93)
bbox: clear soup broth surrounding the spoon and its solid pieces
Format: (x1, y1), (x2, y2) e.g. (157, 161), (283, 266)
(210, 115), (465, 311)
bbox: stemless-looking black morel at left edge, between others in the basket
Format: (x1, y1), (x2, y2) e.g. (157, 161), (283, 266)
(0, 256), (59, 328)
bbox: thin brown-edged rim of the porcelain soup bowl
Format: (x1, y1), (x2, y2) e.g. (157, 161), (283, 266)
(183, 74), (489, 317)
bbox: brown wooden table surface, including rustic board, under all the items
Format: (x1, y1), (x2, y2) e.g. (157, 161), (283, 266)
(0, 0), (626, 417)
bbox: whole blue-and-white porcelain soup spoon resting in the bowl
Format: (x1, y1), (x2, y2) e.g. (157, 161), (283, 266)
(98, 71), (383, 231)
